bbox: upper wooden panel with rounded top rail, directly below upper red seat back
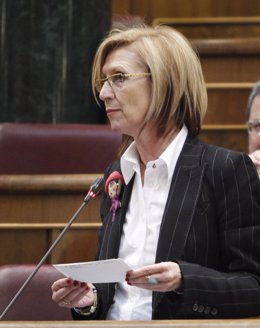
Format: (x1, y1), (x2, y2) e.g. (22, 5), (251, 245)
(0, 174), (102, 223)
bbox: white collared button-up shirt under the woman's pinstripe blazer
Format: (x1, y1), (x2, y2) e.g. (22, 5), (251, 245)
(107, 126), (188, 320)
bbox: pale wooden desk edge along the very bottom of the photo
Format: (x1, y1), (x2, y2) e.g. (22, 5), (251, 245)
(0, 319), (260, 328)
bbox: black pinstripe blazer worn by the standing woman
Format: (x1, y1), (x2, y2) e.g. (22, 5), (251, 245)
(74, 136), (260, 319)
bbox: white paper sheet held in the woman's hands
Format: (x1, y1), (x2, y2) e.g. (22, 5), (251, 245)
(53, 259), (131, 283)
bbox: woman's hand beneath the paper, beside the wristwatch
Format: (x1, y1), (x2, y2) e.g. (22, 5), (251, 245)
(51, 278), (94, 308)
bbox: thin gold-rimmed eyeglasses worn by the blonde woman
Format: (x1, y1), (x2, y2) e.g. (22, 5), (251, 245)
(95, 73), (151, 93)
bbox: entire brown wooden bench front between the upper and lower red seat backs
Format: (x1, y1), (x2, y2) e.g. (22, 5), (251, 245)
(0, 174), (101, 264)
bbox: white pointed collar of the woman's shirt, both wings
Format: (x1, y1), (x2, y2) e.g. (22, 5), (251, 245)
(120, 125), (188, 184)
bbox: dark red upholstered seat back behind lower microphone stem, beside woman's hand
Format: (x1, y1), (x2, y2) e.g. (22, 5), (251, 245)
(0, 264), (72, 321)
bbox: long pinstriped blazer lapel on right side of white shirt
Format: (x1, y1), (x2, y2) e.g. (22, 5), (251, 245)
(153, 137), (206, 305)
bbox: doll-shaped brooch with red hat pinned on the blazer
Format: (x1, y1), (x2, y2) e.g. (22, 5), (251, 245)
(105, 171), (124, 222)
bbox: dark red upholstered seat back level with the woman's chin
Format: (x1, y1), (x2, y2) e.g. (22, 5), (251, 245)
(0, 123), (121, 174)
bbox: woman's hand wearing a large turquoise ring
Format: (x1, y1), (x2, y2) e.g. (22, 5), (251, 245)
(126, 262), (182, 292)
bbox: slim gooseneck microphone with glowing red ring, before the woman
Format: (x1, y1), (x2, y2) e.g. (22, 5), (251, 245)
(0, 177), (105, 320)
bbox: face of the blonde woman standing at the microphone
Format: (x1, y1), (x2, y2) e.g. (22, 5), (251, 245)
(99, 46), (152, 138)
